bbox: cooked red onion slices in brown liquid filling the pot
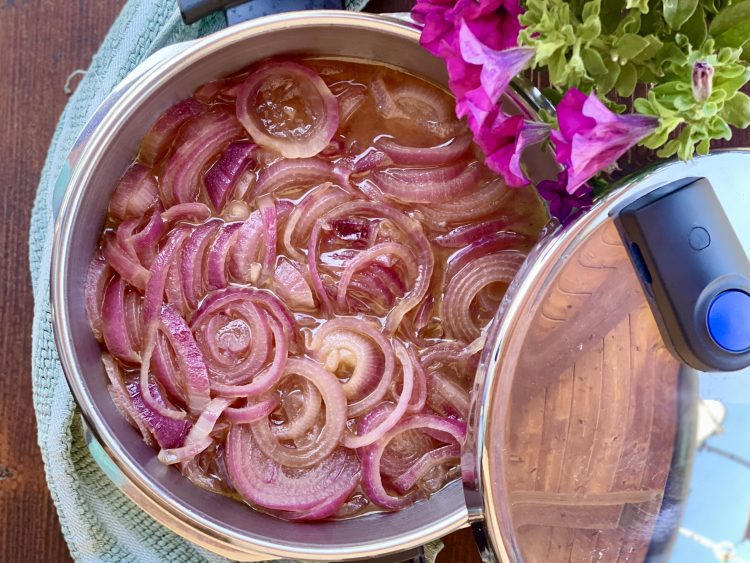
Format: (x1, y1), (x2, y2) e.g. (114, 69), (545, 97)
(87, 59), (547, 520)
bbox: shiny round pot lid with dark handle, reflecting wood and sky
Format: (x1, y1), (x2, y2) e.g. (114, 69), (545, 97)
(463, 151), (750, 563)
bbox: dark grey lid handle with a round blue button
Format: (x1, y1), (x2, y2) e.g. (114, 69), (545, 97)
(612, 178), (750, 371)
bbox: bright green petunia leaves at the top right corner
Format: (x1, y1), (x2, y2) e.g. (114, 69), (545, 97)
(519, 0), (750, 159)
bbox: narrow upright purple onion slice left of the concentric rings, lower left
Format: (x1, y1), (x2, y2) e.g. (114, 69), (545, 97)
(160, 305), (210, 414)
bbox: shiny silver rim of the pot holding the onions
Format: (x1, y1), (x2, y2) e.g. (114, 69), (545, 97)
(50, 10), (476, 560)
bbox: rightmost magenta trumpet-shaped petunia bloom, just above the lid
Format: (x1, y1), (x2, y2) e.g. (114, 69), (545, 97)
(552, 88), (658, 194)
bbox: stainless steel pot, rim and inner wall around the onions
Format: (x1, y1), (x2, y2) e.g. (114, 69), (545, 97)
(51, 11), (543, 561)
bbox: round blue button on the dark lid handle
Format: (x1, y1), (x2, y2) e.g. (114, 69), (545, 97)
(706, 289), (750, 352)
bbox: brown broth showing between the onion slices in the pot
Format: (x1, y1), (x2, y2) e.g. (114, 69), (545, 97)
(97, 58), (548, 517)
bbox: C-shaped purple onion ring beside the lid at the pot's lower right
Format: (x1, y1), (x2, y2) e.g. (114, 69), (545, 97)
(360, 414), (466, 510)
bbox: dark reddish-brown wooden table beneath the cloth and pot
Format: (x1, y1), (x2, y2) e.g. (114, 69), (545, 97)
(0, 0), (479, 563)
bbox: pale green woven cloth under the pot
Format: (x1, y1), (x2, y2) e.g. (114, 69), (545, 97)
(29, 0), (446, 562)
